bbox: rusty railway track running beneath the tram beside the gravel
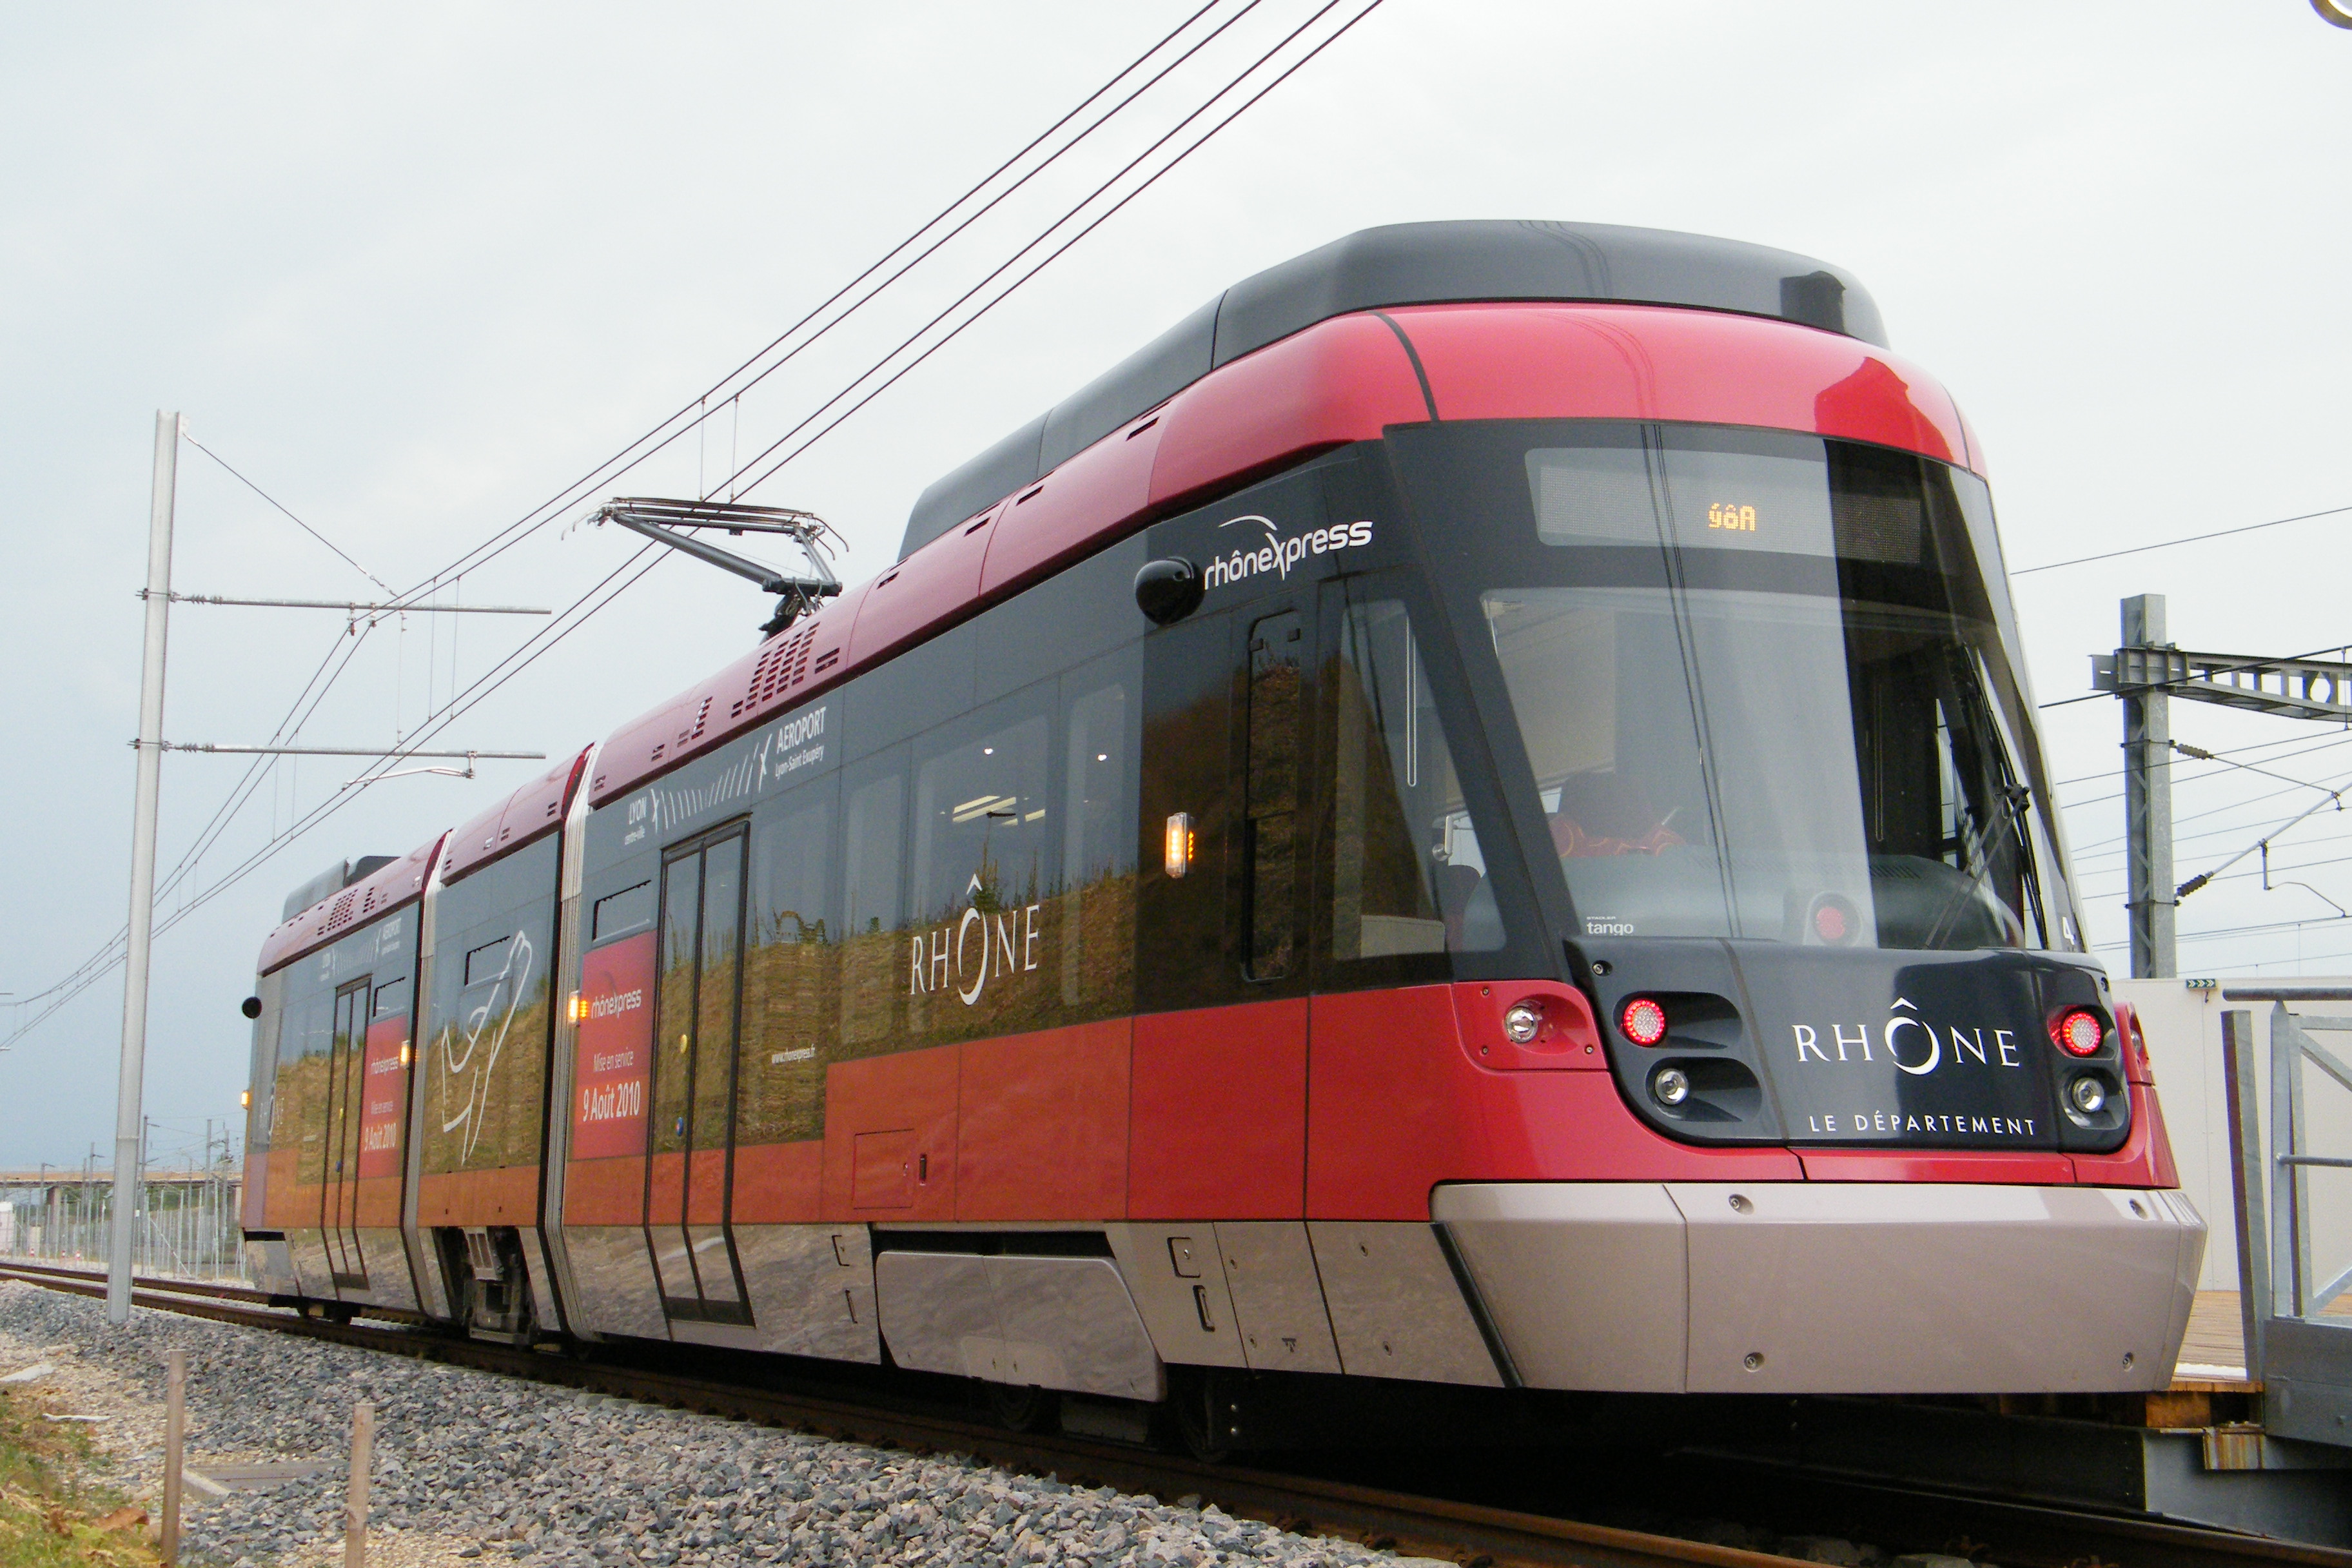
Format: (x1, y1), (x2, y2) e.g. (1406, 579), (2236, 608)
(0, 1262), (2352, 1568)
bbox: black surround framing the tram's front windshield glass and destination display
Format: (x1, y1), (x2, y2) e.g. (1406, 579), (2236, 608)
(1386, 418), (2084, 954)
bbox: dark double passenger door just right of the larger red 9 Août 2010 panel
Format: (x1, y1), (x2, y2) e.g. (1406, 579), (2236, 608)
(645, 825), (750, 1324)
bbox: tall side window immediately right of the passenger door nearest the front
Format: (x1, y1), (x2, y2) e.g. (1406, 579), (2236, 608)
(736, 778), (842, 1145)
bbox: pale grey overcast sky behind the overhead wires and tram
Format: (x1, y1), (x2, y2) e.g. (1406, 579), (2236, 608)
(0, 0), (2352, 1166)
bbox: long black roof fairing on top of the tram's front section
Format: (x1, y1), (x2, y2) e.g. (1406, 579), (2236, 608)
(899, 219), (1886, 560)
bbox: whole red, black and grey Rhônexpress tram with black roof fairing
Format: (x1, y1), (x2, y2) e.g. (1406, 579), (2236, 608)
(244, 223), (2204, 1438)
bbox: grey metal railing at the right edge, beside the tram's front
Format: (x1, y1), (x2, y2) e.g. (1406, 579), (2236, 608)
(2220, 985), (2352, 1446)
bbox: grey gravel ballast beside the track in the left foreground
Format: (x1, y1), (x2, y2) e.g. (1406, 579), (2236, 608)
(0, 1284), (1427, 1568)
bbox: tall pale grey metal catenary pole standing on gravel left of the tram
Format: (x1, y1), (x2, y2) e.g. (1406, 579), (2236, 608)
(106, 414), (179, 1324)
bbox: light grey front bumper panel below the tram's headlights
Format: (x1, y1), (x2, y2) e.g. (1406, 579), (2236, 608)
(1433, 1182), (2204, 1394)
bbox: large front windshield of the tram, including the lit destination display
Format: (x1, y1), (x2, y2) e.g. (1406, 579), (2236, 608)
(1409, 423), (2079, 950)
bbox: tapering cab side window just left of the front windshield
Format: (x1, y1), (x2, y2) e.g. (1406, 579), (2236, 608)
(1331, 585), (1503, 964)
